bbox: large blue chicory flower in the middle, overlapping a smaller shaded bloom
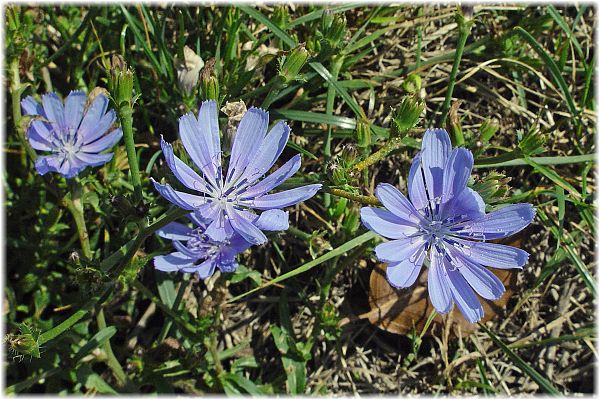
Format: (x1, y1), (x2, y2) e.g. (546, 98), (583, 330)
(152, 101), (321, 244)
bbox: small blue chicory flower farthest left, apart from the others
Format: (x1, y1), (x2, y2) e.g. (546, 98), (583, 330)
(21, 90), (123, 178)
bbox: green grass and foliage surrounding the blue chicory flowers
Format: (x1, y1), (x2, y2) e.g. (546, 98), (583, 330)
(3, 3), (597, 396)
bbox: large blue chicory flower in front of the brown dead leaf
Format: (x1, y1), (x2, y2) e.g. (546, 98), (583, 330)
(361, 129), (535, 323)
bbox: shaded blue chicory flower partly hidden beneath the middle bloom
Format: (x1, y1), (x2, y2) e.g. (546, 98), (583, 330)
(154, 213), (251, 279)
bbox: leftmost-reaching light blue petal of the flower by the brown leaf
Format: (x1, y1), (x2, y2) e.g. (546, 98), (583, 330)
(360, 207), (419, 239)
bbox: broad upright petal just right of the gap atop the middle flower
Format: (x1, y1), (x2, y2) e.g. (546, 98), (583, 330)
(226, 107), (269, 183)
